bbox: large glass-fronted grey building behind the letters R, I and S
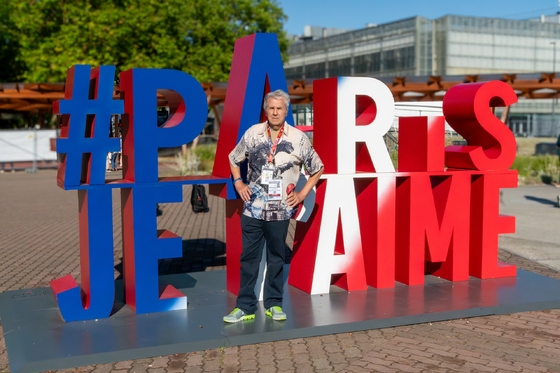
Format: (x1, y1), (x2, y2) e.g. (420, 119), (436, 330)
(285, 15), (560, 136)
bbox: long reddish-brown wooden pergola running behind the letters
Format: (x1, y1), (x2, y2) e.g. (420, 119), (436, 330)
(0, 73), (560, 128)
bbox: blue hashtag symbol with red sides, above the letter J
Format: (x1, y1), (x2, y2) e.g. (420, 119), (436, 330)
(53, 65), (124, 189)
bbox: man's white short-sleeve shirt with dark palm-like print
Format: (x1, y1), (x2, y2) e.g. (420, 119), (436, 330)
(229, 122), (323, 221)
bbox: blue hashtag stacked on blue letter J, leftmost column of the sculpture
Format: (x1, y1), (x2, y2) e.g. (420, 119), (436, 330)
(51, 66), (124, 321)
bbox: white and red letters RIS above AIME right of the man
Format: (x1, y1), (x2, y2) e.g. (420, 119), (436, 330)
(289, 78), (517, 294)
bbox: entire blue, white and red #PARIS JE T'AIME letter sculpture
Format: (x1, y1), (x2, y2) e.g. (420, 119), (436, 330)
(51, 34), (517, 321)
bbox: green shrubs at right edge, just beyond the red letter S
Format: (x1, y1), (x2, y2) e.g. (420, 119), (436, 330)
(511, 155), (560, 184)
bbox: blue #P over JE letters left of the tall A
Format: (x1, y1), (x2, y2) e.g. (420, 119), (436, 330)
(51, 66), (227, 321)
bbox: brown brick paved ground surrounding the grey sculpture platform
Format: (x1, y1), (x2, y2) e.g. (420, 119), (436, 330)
(0, 170), (560, 373)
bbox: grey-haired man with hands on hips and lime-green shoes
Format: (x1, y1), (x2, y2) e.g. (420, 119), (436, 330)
(224, 90), (323, 323)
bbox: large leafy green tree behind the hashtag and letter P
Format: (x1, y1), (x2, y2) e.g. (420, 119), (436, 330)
(10, 0), (288, 82)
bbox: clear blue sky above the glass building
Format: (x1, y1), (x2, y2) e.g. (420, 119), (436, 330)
(277, 0), (560, 35)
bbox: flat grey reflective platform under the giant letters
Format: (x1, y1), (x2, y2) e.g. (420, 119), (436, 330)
(0, 270), (560, 373)
